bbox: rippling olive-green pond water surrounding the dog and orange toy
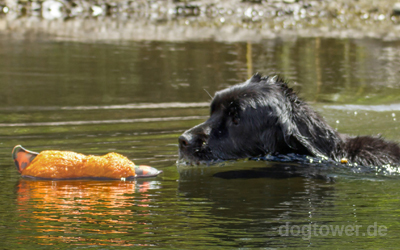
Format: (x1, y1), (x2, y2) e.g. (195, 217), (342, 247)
(0, 36), (400, 249)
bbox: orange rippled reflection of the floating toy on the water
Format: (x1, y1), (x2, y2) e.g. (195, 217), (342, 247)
(17, 179), (159, 245)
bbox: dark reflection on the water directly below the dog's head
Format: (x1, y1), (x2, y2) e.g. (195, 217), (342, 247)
(178, 162), (334, 218)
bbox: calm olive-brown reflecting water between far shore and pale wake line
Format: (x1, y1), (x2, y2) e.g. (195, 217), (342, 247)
(0, 39), (400, 108)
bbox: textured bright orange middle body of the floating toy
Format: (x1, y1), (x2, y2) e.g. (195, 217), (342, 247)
(21, 151), (135, 179)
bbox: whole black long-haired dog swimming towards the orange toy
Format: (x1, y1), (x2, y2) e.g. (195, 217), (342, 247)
(179, 74), (400, 166)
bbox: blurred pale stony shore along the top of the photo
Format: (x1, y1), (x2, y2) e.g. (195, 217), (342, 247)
(0, 0), (400, 42)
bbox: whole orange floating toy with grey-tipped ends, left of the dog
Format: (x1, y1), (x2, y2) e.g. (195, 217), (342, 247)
(12, 145), (162, 180)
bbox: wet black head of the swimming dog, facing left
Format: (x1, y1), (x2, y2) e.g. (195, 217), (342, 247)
(179, 74), (337, 163)
